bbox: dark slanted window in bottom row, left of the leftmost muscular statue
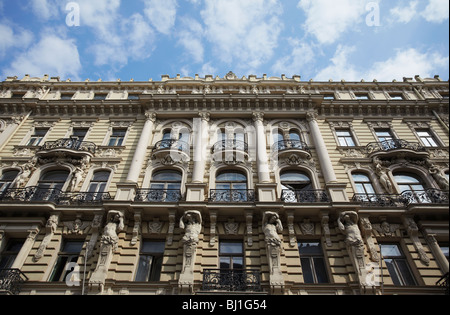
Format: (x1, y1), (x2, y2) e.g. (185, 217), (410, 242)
(50, 240), (84, 282)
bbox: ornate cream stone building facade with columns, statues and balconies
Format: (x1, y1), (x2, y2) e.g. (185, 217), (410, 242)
(0, 72), (449, 295)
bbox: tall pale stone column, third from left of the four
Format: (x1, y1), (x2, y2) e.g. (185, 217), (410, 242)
(253, 112), (270, 184)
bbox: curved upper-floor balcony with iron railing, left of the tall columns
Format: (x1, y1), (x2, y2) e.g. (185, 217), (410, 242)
(36, 138), (97, 158)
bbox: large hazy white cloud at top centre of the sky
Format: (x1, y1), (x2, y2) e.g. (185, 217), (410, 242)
(201, 0), (283, 70)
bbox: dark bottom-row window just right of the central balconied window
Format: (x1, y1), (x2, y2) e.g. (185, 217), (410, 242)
(298, 242), (329, 284)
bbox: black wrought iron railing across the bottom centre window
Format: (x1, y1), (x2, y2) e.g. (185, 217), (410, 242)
(202, 269), (261, 292)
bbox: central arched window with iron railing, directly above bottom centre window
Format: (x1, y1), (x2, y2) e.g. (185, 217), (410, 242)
(211, 171), (254, 202)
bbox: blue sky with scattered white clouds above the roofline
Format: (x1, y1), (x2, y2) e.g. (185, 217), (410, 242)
(0, 0), (449, 82)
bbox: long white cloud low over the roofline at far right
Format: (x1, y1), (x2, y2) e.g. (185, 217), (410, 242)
(314, 45), (449, 82)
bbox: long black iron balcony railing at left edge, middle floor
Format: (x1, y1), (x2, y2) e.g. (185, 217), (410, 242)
(0, 186), (112, 205)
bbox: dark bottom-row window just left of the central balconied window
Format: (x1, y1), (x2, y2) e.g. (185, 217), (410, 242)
(135, 241), (165, 282)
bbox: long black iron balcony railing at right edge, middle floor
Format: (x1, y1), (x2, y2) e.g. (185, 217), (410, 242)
(352, 188), (449, 207)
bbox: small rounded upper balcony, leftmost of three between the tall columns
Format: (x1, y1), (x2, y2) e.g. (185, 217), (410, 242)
(152, 139), (191, 164)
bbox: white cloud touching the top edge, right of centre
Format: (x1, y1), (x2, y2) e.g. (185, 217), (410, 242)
(298, 0), (368, 44)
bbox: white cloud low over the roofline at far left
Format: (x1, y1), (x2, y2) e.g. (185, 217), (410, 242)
(3, 34), (81, 80)
